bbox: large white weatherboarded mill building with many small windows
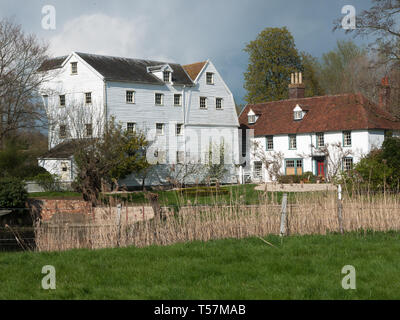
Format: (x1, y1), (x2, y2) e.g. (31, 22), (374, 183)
(39, 52), (239, 186)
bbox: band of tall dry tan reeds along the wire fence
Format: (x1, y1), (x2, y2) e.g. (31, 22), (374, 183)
(36, 192), (400, 251)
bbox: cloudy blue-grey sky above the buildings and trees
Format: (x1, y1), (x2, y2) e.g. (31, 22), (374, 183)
(0, 0), (371, 104)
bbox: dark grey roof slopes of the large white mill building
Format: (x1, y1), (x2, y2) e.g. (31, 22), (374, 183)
(39, 52), (193, 86)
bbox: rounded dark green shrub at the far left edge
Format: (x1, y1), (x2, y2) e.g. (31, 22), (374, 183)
(0, 178), (28, 208)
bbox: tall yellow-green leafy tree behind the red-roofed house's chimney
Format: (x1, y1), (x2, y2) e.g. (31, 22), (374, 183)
(244, 27), (303, 103)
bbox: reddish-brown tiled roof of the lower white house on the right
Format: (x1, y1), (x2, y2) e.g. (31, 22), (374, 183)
(239, 94), (400, 136)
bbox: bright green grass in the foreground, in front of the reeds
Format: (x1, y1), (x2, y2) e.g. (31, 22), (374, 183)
(0, 232), (400, 299)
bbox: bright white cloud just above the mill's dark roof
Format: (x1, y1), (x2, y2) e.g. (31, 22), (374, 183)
(49, 13), (172, 60)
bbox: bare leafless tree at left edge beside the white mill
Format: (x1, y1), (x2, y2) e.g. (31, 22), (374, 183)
(0, 19), (48, 146)
